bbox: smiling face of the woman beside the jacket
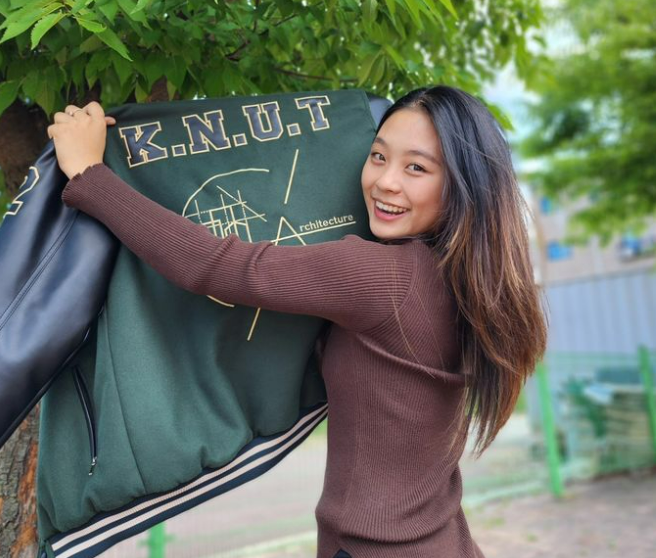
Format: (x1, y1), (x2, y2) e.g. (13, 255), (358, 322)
(362, 109), (444, 240)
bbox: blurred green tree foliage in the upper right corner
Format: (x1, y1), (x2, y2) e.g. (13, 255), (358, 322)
(523, 0), (656, 242)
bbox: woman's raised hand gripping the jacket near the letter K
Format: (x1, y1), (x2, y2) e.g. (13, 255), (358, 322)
(48, 101), (116, 179)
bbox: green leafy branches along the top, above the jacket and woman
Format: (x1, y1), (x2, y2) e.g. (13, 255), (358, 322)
(0, 0), (542, 114)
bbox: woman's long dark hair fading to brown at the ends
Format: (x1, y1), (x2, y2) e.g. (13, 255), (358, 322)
(378, 86), (547, 457)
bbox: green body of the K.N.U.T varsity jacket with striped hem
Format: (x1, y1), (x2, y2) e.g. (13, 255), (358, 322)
(37, 90), (384, 558)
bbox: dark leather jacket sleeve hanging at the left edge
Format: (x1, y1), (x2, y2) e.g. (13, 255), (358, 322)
(0, 142), (118, 447)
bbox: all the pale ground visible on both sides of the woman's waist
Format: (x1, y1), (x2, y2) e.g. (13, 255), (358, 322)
(102, 417), (656, 558)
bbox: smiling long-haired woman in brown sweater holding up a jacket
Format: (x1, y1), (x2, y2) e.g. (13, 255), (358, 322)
(49, 86), (546, 558)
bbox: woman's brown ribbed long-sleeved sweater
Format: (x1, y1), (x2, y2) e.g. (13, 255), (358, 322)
(62, 164), (483, 558)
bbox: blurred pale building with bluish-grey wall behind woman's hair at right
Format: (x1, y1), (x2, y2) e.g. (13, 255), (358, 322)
(533, 197), (656, 352)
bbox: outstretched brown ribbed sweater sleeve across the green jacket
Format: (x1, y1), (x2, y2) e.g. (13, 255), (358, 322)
(62, 164), (416, 331)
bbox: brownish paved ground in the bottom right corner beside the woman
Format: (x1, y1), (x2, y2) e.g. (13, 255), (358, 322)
(466, 469), (656, 558)
